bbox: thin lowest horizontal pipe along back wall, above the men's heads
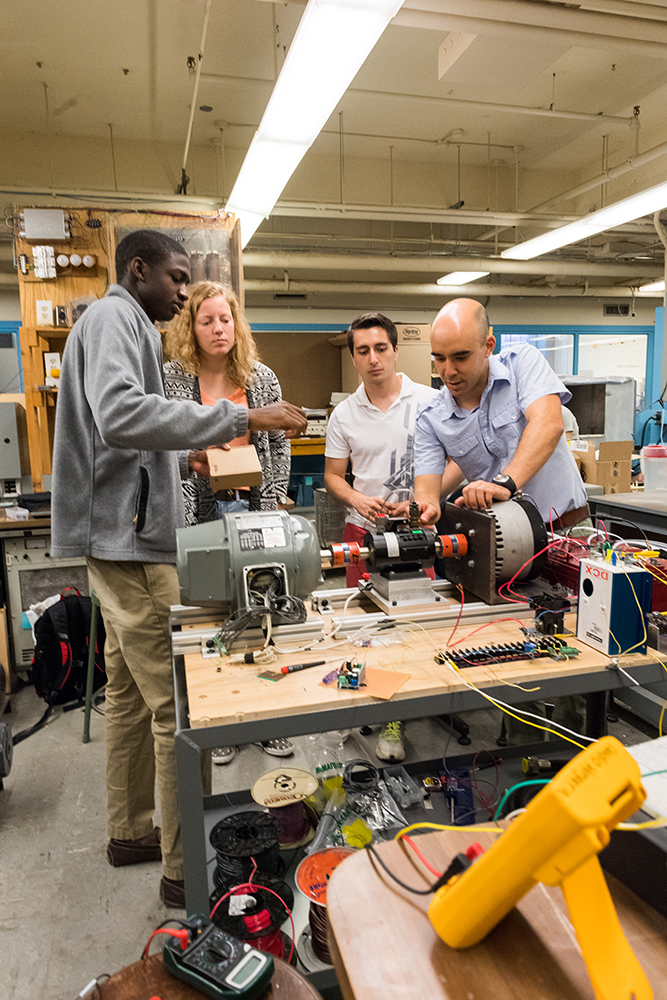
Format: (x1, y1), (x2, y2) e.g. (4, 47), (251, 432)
(244, 279), (662, 299)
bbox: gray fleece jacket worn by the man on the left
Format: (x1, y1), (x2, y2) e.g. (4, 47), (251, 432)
(51, 285), (248, 563)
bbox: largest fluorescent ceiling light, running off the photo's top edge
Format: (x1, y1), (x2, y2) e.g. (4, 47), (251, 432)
(226, 0), (403, 247)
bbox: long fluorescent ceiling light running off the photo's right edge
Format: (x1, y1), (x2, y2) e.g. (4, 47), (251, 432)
(500, 181), (667, 260)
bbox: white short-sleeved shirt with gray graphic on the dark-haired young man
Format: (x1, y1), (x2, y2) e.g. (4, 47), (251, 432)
(324, 374), (438, 529)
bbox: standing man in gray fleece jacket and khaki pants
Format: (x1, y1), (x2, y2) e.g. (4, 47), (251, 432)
(51, 230), (306, 907)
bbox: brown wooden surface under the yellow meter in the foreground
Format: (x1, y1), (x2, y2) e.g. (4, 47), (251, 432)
(327, 830), (667, 1000)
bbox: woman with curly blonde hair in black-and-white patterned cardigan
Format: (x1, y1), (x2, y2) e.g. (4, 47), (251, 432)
(164, 281), (290, 524)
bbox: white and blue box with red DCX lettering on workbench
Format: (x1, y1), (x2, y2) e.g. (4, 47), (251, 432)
(577, 554), (653, 656)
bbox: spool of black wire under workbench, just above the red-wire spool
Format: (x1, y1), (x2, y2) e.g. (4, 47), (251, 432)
(209, 810), (285, 888)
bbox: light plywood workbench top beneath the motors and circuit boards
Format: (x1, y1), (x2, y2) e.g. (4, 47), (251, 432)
(184, 614), (658, 727)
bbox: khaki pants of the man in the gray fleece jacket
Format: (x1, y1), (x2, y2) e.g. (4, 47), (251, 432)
(87, 557), (183, 879)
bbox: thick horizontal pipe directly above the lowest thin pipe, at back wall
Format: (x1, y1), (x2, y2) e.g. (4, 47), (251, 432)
(243, 250), (663, 287)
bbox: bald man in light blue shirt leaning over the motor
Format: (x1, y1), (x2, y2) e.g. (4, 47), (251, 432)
(415, 299), (588, 527)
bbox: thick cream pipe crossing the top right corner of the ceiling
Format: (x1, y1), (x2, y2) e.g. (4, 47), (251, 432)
(392, 0), (667, 58)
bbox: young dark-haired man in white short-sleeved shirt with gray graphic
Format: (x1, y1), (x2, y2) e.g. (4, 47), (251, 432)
(324, 313), (438, 760)
